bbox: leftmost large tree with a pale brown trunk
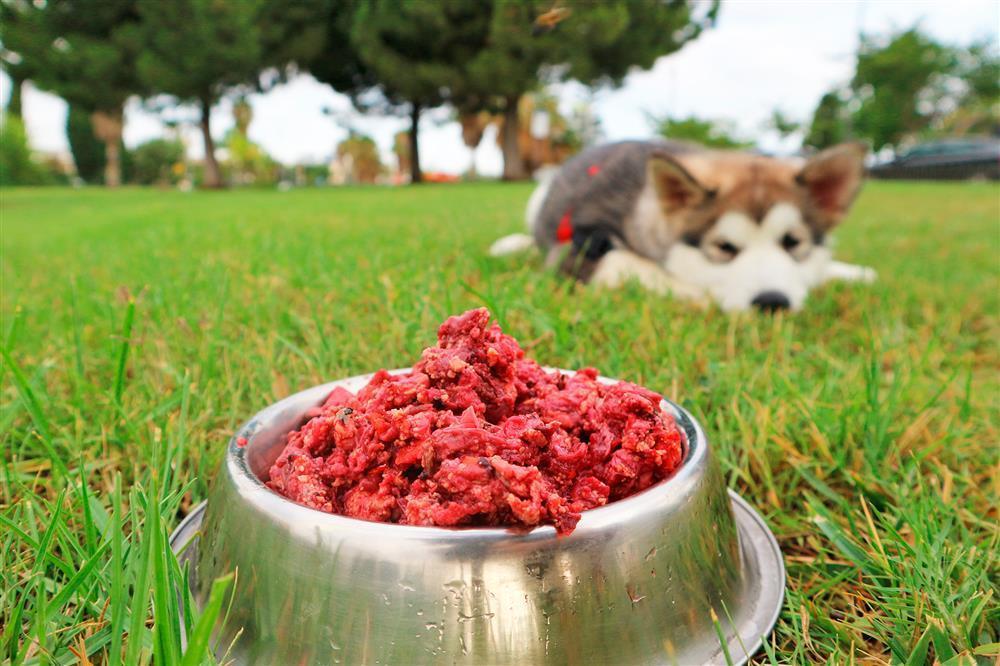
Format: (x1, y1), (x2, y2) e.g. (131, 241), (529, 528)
(0, 0), (144, 187)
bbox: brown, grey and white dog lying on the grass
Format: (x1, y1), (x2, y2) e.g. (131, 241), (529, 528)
(490, 141), (875, 311)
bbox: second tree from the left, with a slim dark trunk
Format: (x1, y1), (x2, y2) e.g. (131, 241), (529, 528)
(138, 0), (264, 188)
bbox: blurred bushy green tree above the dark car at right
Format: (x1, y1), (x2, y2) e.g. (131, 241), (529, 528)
(851, 27), (955, 151)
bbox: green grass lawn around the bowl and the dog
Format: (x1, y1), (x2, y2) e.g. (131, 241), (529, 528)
(0, 183), (1000, 664)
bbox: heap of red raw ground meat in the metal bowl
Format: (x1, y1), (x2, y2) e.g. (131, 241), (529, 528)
(267, 309), (684, 534)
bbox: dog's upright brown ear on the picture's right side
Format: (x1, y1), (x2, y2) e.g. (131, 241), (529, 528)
(795, 141), (868, 227)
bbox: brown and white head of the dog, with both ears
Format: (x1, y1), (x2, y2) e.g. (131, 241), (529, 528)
(648, 143), (866, 310)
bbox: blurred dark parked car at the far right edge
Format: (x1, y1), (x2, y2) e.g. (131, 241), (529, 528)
(869, 138), (1000, 180)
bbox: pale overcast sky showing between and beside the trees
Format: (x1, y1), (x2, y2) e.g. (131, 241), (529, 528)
(0, 0), (1000, 175)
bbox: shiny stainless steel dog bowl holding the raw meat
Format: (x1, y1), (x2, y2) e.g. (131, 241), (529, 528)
(171, 375), (785, 666)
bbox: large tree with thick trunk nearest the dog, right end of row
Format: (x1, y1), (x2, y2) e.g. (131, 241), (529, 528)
(453, 0), (718, 179)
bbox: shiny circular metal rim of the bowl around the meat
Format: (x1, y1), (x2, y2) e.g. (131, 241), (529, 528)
(223, 366), (709, 542)
